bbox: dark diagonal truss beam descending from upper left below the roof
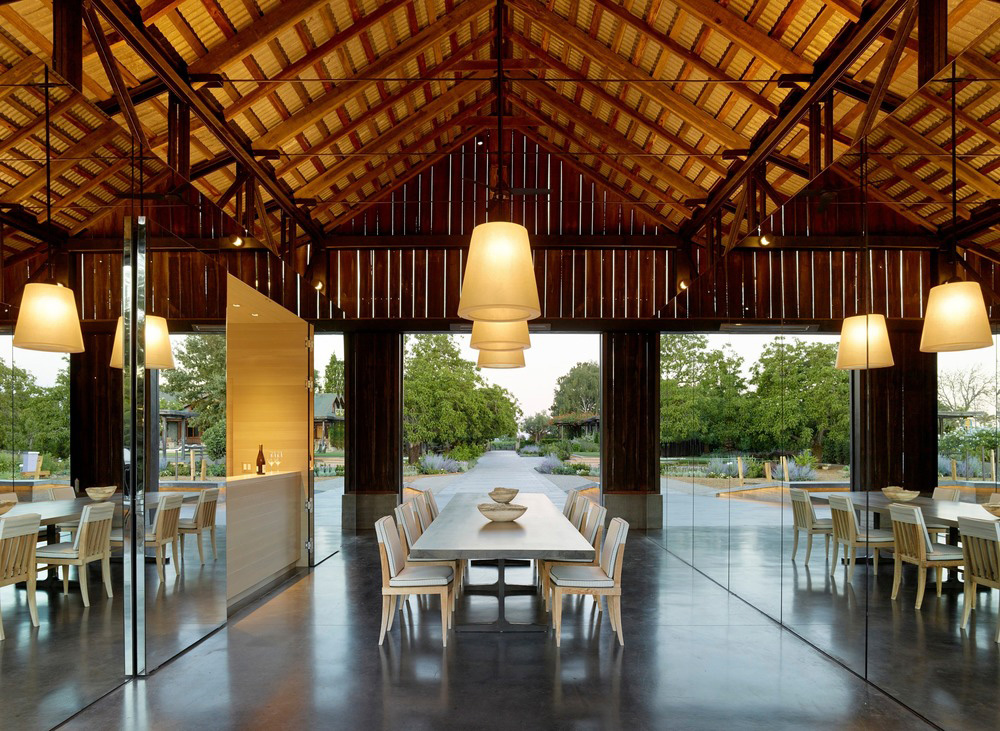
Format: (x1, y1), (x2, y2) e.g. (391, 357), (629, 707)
(93, 0), (320, 243)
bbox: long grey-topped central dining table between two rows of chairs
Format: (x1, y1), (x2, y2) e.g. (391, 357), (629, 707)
(410, 493), (594, 632)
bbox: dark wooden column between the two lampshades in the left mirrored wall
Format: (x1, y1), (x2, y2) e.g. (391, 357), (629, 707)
(69, 330), (123, 490)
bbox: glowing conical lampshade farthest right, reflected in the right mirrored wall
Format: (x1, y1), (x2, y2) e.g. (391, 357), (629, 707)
(920, 282), (993, 353)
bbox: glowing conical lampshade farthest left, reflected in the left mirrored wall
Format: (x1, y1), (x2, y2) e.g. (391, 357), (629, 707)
(14, 283), (83, 353)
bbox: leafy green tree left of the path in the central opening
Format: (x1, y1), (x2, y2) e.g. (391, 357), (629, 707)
(403, 335), (521, 456)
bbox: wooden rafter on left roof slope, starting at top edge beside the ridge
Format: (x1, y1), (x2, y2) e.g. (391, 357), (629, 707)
(256, 0), (493, 148)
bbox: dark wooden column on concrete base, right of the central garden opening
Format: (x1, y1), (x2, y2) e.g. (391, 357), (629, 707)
(601, 332), (663, 529)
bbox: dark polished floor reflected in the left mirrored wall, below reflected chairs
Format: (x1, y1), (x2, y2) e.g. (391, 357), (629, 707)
(0, 498), (226, 731)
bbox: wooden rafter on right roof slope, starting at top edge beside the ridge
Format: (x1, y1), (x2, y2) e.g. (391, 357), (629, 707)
(509, 0), (747, 147)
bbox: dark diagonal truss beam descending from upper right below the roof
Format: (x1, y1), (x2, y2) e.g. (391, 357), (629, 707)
(683, 0), (907, 239)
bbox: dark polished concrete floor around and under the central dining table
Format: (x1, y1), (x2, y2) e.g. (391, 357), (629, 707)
(66, 532), (924, 730)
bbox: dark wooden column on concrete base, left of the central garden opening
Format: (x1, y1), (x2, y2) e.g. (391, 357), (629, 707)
(342, 332), (403, 530)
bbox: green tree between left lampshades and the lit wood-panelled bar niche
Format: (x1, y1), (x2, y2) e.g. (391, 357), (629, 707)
(163, 335), (226, 430)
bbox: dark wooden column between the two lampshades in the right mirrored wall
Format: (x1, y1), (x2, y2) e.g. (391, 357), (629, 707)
(851, 327), (937, 492)
